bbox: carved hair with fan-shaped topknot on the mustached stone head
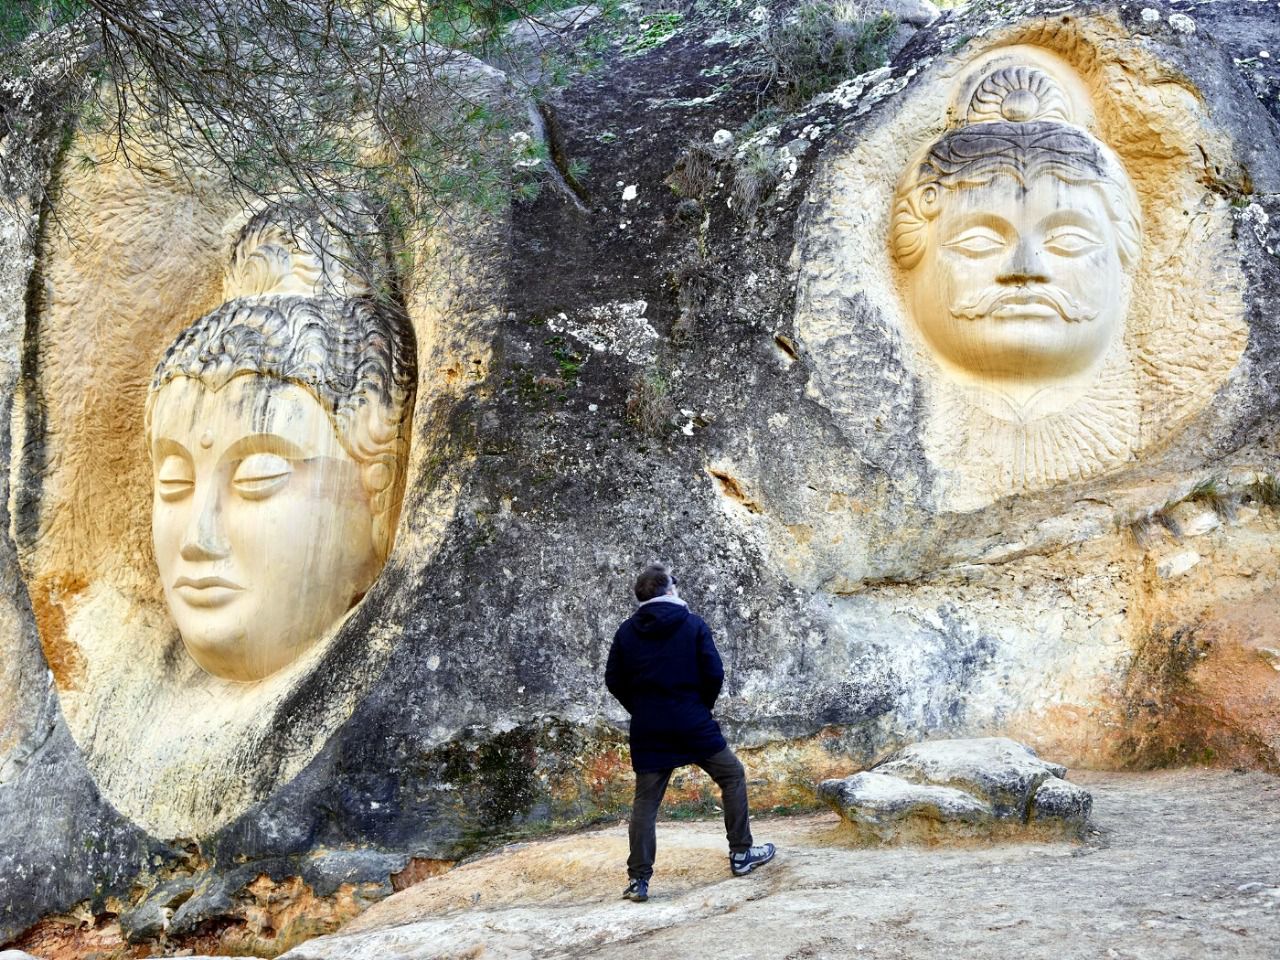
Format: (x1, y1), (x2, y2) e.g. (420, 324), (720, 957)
(890, 67), (1142, 270)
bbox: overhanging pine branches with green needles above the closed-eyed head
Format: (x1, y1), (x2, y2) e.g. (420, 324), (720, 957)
(0, 0), (614, 288)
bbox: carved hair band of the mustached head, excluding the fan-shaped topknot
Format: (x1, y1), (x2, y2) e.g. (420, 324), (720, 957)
(890, 120), (1142, 270)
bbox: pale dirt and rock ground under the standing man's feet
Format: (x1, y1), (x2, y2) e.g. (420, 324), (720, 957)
(287, 771), (1280, 960)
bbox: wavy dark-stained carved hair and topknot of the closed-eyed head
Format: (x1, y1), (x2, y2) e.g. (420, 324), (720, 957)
(146, 208), (417, 561)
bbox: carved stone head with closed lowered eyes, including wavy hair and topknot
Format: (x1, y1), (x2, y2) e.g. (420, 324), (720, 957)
(147, 204), (413, 681)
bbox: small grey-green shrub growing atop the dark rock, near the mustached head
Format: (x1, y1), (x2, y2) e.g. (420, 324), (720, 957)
(759, 0), (897, 109)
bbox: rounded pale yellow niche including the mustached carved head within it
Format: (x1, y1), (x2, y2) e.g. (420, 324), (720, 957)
(796, 17), (1247, 511)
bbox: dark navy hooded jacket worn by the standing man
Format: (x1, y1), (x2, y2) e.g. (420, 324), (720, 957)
(604, 598), (727, 773)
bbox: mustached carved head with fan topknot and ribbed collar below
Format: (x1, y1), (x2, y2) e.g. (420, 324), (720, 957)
(890, 65), (1142, 489)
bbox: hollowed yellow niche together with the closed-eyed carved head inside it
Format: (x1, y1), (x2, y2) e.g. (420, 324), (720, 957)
(13, 160), (430, 837)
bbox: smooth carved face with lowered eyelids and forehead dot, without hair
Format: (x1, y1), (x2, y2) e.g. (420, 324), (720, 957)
(151, 375), (380, 681)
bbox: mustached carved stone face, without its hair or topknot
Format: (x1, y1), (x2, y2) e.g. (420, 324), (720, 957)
(909, 173), (1128, 381)
